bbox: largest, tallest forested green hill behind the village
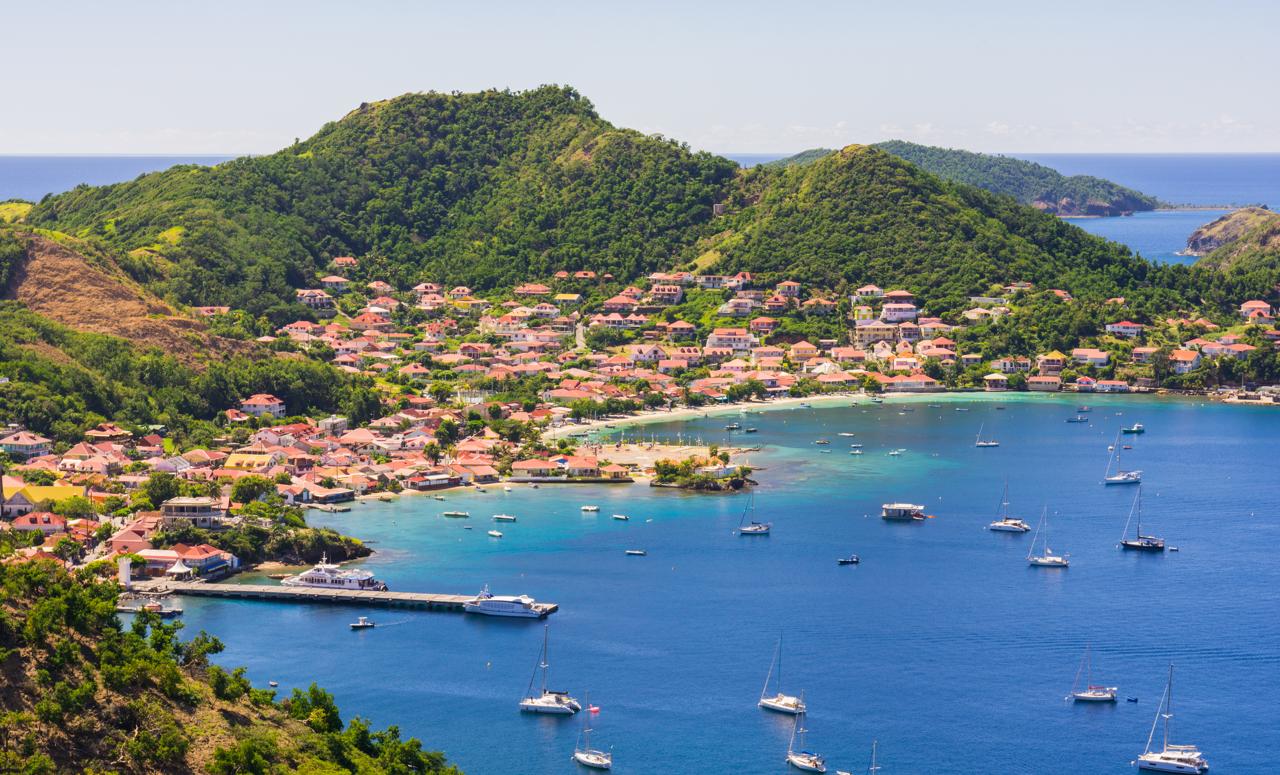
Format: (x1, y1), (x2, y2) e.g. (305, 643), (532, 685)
(27, 87), (736, 320)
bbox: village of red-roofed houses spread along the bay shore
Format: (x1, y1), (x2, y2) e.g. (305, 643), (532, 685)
(0, 256), (1280, 575)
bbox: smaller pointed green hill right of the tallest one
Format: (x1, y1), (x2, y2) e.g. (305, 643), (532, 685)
(700, 146), (1172, 310)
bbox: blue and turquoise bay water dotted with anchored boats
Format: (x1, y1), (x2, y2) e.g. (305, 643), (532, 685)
(177, 396), (1280, 774)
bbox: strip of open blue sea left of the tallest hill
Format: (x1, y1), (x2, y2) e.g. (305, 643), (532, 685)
(0, 155), (232, 201)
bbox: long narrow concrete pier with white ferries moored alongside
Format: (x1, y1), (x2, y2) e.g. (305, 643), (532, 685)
(133, 579), (559, 616)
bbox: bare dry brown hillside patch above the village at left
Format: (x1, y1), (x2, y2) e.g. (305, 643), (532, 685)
(4, 233), (248, 363)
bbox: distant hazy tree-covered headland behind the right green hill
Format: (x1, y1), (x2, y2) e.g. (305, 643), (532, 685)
(876, 140), (1161, 215)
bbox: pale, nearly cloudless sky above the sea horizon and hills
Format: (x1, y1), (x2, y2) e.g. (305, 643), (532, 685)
(0, 0), (1280, 154)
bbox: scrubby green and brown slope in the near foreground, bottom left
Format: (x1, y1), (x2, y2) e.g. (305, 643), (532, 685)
(0, 558), (458, 775)
